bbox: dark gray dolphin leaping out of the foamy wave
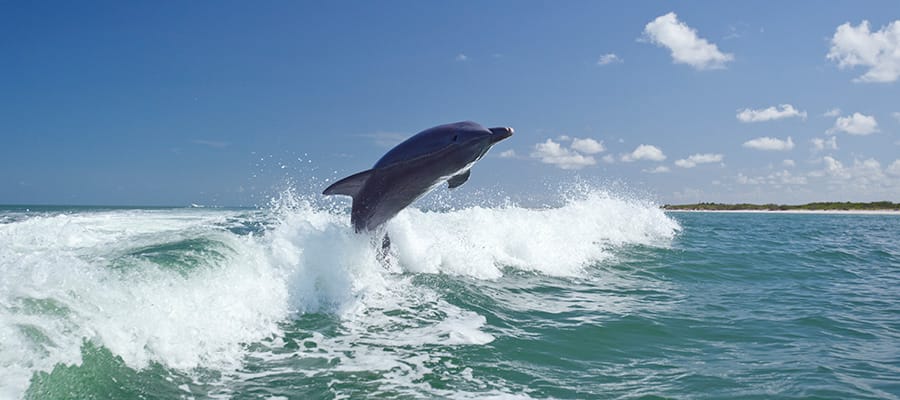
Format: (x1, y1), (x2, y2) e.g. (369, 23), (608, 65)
(322, 121), (513, 232)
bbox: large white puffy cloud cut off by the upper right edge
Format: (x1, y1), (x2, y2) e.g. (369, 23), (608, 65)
(828, 20), (900, 82)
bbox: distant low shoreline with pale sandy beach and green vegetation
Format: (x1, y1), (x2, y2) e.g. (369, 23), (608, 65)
(661, 201), (900, 215)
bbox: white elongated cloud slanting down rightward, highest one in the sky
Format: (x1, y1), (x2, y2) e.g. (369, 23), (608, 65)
(644, 12), (734, 70)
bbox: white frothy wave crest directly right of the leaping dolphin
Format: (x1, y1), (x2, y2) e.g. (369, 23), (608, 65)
(389, 191), (679, 278)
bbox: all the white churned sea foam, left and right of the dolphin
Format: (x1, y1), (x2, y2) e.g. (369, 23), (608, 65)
(0, 191), (679, 398)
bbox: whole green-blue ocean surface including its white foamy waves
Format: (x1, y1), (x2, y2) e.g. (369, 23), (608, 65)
(0, 190), (900, 399)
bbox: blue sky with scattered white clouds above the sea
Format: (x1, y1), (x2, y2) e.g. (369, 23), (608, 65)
(0, 0), (900, 206)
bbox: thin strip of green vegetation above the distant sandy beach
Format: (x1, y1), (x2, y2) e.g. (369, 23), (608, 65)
(661, 201), (900, 212)
